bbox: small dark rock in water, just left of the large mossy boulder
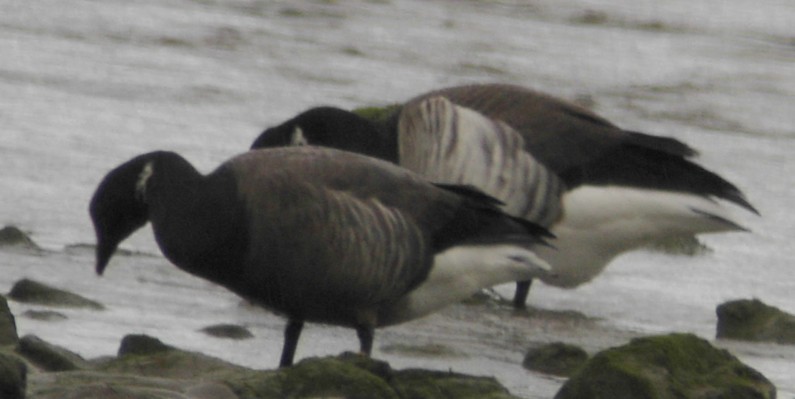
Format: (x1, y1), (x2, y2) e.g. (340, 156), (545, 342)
(522, 342), (588, 377)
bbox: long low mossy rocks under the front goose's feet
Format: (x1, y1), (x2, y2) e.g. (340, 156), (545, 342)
(26, 335), (528, 399)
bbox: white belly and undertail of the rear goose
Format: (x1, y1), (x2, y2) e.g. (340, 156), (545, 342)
(536, 186), (742, 288)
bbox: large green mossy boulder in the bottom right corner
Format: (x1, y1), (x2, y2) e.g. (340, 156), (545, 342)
(555, 334), (776, 399)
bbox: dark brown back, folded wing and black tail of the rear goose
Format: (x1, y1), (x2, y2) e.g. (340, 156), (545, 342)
(406, 84), (756, 212)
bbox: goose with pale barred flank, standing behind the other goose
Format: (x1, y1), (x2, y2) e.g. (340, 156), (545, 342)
(252, 84), (757, 308)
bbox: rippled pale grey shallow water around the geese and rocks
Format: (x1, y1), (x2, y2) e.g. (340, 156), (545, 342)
(0, 0), (795, 398)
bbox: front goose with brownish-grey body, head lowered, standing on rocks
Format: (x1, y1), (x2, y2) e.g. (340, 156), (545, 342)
(89, 148), (549, 366)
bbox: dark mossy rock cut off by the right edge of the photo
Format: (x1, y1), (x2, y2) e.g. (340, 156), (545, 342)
(716, 299), (795, 345)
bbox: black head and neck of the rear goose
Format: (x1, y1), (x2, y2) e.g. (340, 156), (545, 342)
(251, 107), (397, 162)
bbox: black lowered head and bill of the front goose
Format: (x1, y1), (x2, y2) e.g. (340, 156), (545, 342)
(88, 153), (155, 274)
